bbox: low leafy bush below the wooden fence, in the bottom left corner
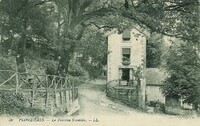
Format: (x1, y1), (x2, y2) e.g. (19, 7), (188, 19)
(0, 91), (45, 115)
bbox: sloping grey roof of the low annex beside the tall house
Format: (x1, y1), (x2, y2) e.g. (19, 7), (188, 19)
(146, 68), (166, 85)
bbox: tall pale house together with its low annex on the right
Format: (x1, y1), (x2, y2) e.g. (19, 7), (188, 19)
(107, 29), (173, 107)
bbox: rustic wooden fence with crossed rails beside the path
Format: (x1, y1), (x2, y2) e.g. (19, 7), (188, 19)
(0, 70), (78, 114)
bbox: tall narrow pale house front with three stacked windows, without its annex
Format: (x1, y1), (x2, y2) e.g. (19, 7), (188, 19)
(107, 29), (146, 107)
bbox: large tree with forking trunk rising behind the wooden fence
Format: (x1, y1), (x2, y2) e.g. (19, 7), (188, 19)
(41, 0), (116, 76)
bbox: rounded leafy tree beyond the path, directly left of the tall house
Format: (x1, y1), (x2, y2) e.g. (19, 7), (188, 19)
(76, 29), (107, 79)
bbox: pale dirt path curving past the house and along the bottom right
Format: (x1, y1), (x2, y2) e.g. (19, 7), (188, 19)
(74, 80), (200, 126)
